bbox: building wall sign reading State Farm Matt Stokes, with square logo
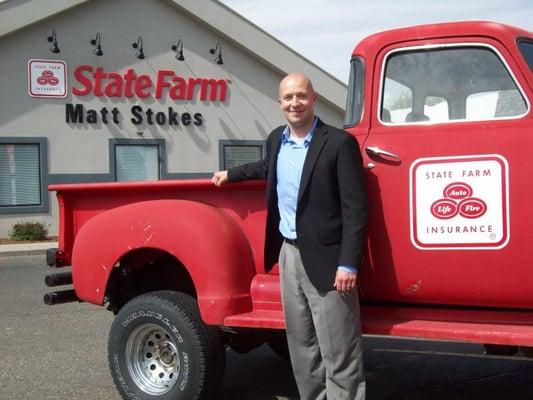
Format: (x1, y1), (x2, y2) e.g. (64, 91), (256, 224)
(28, 60), (231, 127)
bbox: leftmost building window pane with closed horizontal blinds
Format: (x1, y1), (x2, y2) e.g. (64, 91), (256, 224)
(0, 143), (42, 207)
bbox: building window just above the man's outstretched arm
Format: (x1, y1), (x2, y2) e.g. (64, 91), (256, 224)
(220, 140), (264, 170)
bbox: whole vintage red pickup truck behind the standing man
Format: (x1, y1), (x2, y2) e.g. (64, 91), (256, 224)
(45, 22), (533, 399)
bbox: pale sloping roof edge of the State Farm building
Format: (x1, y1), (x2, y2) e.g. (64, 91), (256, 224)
(0, 0), (348, 111)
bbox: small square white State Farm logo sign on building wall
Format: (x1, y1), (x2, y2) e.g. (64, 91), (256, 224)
(28, 60), (67, 98)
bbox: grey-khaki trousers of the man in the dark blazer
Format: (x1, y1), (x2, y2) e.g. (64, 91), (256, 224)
(279, 242), (365, 400)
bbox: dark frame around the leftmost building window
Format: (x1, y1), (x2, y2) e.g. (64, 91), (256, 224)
(0, 137), (50, 214)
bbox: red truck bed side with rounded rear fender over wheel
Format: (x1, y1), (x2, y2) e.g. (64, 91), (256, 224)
(50, 180), (274, 328)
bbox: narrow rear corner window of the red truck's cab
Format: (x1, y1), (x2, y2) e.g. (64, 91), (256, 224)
(344, 57), (365, 128)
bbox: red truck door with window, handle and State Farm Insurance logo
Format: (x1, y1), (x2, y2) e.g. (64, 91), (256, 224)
(362, 38), (533, 307)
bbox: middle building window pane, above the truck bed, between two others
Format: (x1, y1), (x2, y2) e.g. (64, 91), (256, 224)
(114, 144), (160, 181)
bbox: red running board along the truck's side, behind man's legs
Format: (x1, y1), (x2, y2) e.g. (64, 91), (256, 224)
(224, 305), (533, 346)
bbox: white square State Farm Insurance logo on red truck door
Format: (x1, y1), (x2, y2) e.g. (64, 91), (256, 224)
(410, 155), (509, 250)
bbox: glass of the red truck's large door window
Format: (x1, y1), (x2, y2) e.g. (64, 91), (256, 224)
(380, 45), (527, 124)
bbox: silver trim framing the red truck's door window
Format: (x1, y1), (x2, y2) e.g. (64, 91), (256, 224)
(375, 42), (531, 126)
